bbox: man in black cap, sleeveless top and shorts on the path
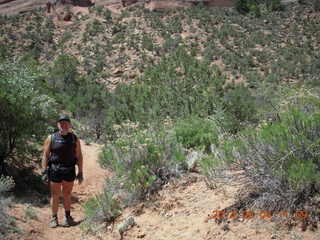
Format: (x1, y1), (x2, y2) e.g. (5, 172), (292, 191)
(42, 116), (83, 228)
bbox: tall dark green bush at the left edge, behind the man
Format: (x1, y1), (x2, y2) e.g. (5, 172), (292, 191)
(0, 59), (56, 173)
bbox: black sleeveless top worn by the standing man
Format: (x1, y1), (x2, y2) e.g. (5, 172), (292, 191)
(49, 132), (77, 167)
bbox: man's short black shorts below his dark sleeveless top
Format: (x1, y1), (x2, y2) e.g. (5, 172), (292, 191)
(49, 165), (76, 183)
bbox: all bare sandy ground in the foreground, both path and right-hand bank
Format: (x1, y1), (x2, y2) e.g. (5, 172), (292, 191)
(10, 143), (320, 240)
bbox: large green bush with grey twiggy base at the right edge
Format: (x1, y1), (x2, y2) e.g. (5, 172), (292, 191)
(205, 95), (320, 211)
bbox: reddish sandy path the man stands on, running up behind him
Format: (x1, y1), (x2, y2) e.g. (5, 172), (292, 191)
(8, 142), (108, 240)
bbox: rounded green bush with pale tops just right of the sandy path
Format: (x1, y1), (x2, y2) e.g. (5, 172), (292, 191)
(100, 122), (184, 199)
